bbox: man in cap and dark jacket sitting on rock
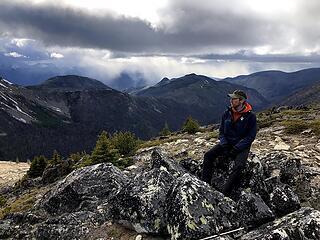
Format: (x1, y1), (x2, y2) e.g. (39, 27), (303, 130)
(202, 90), (257, 196)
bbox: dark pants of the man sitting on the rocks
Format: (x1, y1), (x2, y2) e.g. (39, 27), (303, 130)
(202, 144), (250, 196)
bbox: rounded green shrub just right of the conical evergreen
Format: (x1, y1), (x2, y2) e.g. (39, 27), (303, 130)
(111, 132), (138, 156)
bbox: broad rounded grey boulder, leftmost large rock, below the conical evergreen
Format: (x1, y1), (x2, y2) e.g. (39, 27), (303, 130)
(40, 163), (128, 214)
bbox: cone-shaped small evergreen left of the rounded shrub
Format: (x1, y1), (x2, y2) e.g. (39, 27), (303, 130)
(91, 131), (119, 165)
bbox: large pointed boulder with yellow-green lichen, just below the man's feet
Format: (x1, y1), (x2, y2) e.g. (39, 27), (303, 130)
(167, 174), (239, 239)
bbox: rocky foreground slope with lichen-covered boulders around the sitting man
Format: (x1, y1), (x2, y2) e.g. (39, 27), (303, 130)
(0, 109), (320, 240)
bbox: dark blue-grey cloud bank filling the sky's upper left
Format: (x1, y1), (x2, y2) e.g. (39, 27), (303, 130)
(0, 1), (157, 51)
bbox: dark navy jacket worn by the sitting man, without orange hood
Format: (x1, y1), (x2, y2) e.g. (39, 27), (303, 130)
(219, 102), (257, 151)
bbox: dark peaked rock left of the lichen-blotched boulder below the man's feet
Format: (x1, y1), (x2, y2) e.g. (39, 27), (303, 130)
(106, 149), (185, 233)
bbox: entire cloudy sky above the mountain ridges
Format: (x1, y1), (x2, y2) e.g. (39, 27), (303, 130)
(0, 0), (320, 86)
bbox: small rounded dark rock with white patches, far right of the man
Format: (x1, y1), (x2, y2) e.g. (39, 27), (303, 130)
(270, 185), (300, 216)
